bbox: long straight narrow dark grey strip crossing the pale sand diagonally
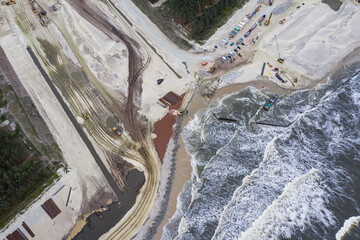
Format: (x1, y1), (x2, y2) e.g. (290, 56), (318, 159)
(27, 47), (123, 200)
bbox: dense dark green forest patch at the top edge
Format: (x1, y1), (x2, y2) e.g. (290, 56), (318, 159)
(168, 0), (247, 40)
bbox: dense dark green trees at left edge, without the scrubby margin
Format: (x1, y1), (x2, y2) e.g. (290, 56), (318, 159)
(0, 125), (54, 227)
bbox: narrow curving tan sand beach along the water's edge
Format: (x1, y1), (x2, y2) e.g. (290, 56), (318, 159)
(152, 48), (360, 239)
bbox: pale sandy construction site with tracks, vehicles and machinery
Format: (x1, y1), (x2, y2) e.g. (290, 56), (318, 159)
(0, 0), (360, 239)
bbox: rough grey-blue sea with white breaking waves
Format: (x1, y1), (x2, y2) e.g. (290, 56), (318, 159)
(162, 64), (360, 240)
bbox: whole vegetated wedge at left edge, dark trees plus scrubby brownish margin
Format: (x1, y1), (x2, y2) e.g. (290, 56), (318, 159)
(0, 72), (63, 229)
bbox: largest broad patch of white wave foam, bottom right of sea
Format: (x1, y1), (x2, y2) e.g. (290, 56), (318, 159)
(240, 169), (334, 240)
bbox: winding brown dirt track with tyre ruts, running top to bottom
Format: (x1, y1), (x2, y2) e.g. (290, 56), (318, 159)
(64, 0), (160, 239)
